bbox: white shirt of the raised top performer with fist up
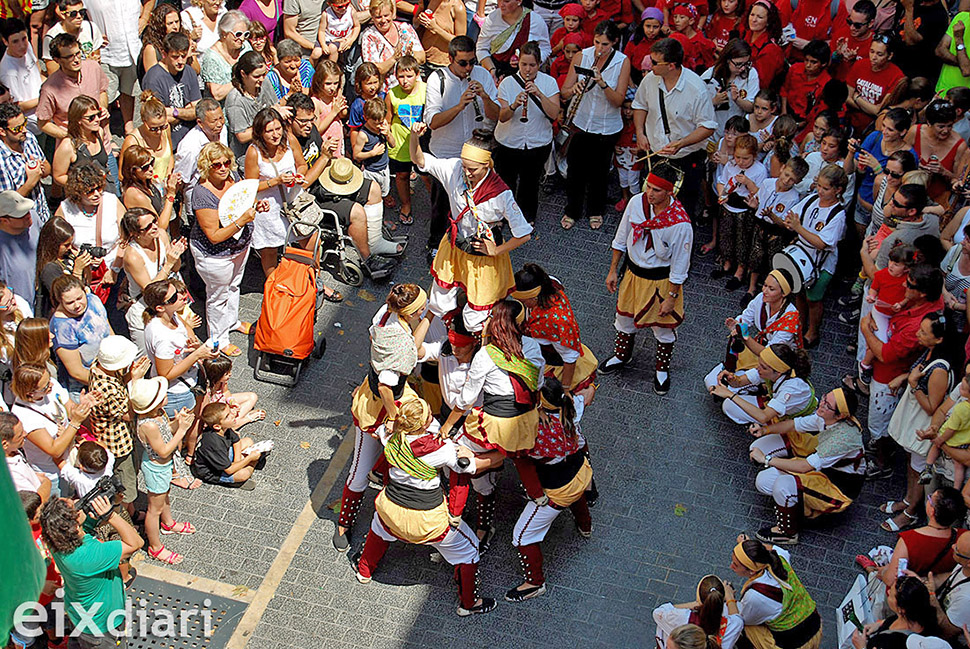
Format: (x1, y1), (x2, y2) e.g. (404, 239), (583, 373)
(421, 154), (533, 238)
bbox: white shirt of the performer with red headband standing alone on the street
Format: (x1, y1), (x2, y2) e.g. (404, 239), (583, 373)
(612, 194), (694, 284)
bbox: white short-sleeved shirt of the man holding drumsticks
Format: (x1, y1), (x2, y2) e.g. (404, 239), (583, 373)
(633, 70), (716, 158)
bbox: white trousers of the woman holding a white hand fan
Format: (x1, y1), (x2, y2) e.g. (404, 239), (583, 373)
(189, 245), (249, 347)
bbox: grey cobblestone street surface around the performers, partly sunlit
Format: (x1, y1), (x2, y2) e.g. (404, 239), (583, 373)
(147, 183), (903, 649)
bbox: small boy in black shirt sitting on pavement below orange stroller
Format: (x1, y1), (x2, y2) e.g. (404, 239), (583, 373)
(192, 403), (266, 491)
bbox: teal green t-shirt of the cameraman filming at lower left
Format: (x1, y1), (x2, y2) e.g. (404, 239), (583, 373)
(54, 534), (125, 633)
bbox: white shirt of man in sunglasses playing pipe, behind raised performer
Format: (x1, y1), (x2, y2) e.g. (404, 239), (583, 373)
(424, 65), (498, 158)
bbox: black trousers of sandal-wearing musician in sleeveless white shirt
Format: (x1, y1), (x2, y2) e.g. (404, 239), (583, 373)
(566, 131), (620, 219)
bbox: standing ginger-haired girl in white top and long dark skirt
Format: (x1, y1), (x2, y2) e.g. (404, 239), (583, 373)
(711, 134), (768, 296)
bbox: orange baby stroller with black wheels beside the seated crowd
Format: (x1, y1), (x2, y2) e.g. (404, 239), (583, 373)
(253, 218), (330, 387)
